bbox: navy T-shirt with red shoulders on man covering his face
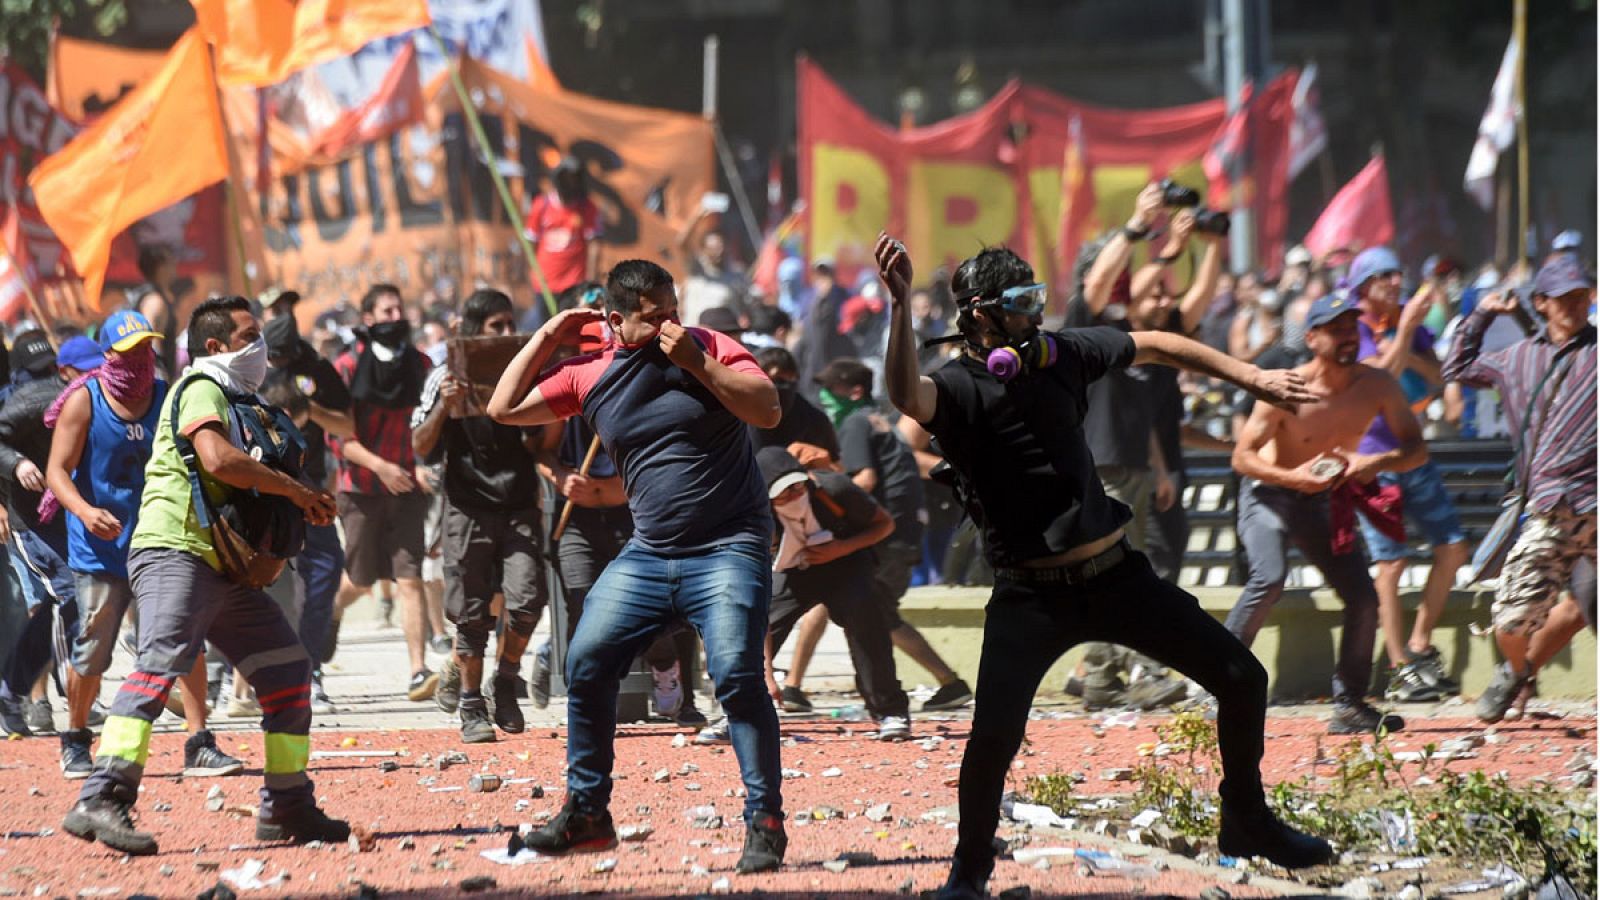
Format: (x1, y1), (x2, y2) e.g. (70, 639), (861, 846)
(538, 328), (773, 556)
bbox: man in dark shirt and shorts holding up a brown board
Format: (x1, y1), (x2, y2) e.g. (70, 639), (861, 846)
(411, 290), (546, 743)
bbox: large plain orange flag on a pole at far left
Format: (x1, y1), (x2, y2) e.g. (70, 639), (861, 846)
(27, 29), (227, 304)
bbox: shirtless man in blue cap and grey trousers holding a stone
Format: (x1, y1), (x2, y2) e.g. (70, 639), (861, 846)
(1227, 293), (1427, 735)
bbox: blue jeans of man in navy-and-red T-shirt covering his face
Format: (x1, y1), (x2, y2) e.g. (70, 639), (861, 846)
(566, 541), (782, 822)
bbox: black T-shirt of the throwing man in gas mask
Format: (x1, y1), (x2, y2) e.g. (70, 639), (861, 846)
(926, 328), (1134, 565)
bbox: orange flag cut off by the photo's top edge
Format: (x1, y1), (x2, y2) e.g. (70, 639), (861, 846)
(190, 0), (432, 86)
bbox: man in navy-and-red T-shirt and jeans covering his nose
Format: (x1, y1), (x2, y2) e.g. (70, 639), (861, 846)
(488, 259), (787, 873)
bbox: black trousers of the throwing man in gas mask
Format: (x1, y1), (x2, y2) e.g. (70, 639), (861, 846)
(955, 551), (1267, 879)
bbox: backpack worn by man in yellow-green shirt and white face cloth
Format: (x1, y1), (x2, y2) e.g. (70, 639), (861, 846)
(170, 375), (306, 588)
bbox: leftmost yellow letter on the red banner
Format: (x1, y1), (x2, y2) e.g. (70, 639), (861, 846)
(810, 144), (890, 258)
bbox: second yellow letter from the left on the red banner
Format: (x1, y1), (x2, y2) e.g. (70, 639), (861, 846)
(906, 162), (1018, 271)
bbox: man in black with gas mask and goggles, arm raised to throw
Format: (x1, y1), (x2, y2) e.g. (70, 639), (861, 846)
(875, 235), (1333, 898)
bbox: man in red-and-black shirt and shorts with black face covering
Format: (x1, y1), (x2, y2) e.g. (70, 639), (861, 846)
(333, 283), (438, 701)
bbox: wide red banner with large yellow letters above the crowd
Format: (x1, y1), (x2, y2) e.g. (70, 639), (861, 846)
(798, 58), (1293, 294)
